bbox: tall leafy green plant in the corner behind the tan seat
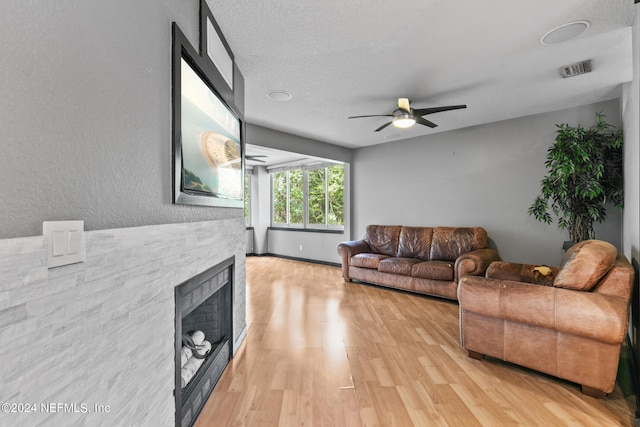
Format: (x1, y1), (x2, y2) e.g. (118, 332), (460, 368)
(528, 113), (624, 242)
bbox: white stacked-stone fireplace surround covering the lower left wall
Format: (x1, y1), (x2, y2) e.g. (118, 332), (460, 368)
(0, 218), (246, 426)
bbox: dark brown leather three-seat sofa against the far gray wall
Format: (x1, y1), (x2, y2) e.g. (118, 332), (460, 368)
(338, 225), (500, 300)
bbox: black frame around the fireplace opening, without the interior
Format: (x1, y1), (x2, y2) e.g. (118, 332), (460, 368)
(174, 256), (235, 427)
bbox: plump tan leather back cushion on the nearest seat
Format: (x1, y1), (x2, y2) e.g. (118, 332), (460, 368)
(553, 240), (618, 291)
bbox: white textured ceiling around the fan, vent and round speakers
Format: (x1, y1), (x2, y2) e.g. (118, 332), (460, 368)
(208, 0), (634, 148)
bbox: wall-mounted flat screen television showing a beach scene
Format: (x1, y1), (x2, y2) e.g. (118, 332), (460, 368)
(173, 24), (244, 208)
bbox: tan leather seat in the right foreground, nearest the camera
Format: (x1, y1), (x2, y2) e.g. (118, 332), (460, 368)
(458, 240), (634, 398)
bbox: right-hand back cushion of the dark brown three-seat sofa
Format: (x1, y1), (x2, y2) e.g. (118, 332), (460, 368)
(429, 227), (487, 261)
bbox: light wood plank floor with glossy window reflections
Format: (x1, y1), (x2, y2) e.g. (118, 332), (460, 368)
(196, 257), (635, 427)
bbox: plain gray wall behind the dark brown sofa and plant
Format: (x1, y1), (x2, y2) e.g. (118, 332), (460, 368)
(351, 100), (621, 265)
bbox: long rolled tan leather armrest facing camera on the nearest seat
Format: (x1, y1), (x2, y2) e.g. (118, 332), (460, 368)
(458, 276), (629, 345)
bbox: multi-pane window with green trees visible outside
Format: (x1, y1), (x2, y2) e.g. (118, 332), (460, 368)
(271, 164), (344, 228)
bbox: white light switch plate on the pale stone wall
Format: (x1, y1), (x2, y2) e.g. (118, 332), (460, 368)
(42, 221), (87, 268)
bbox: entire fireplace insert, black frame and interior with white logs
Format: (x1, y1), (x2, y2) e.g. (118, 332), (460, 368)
(174, 257), (235, 427)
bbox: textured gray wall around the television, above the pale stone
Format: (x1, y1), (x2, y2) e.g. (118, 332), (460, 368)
(0, 0), (242, 238)
